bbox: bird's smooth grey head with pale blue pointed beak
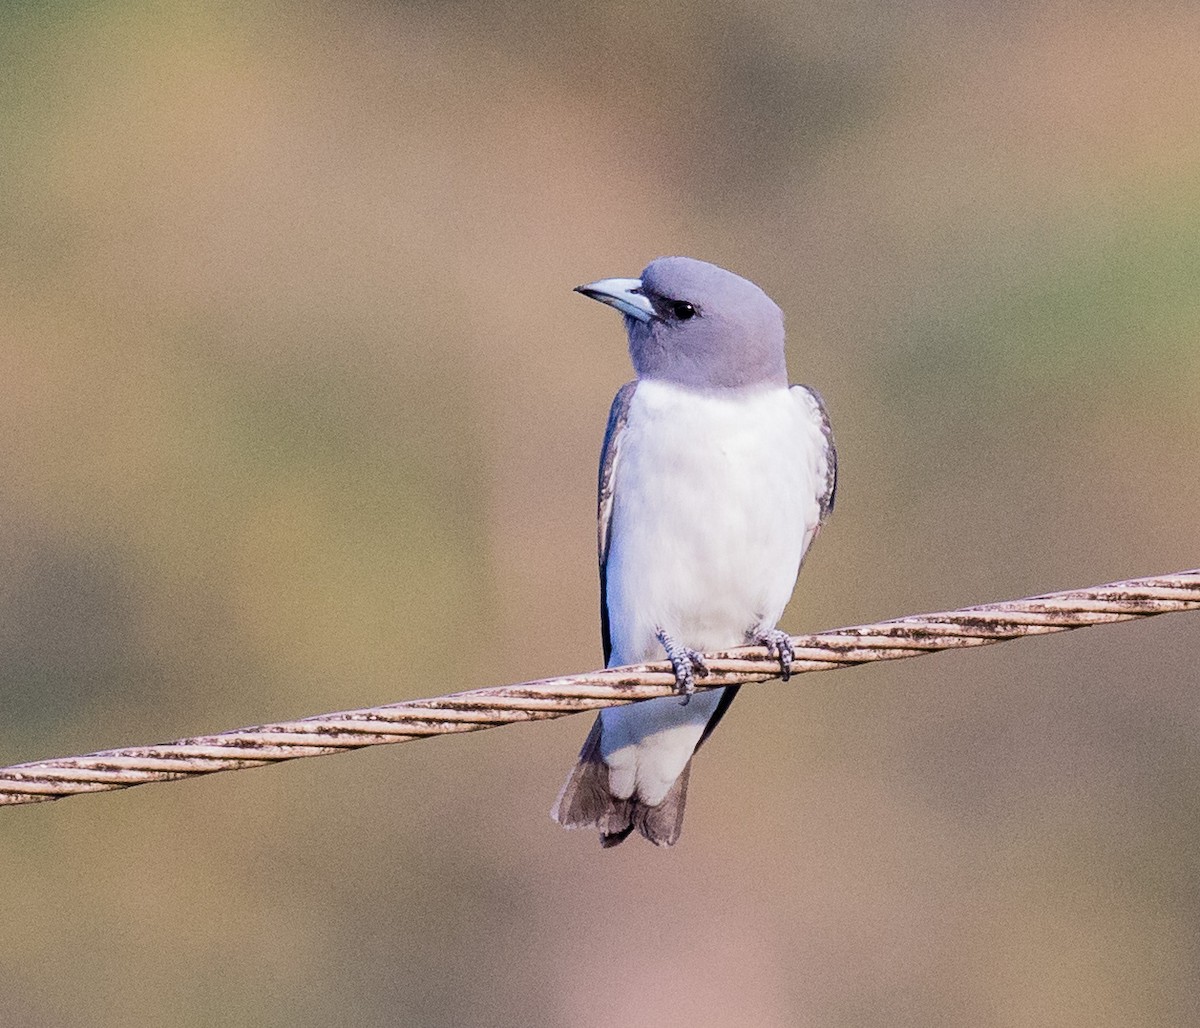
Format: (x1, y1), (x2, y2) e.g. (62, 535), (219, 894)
(576, 257), (787, 389)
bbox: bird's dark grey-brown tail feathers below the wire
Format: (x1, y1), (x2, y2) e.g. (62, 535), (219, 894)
(550, 717), (691, 849)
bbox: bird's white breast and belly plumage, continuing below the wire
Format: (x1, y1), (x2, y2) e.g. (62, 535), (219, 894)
(601, 381), (826, 805)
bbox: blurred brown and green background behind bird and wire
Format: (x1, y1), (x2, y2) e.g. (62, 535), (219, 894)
(0, 0), (1200, 1028)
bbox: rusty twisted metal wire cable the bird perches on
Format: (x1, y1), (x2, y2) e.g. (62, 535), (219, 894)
(0, 569), (1200, 805)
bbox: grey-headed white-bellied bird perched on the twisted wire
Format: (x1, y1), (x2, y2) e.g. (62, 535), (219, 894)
(551, 257), (838, 848)
